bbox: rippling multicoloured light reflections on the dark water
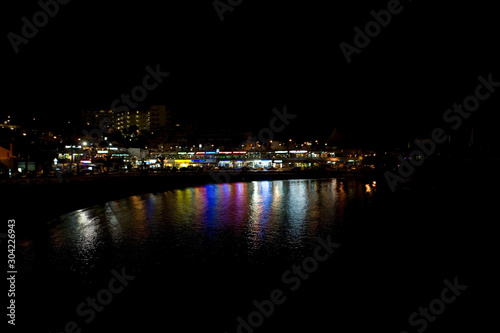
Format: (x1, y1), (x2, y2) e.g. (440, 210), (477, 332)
(21, 179), (373, 278)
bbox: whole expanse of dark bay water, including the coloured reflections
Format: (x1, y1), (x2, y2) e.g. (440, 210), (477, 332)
(13, 178), (493, 333)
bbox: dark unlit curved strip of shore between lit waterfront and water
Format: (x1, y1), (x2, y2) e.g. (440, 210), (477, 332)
(1, 172), (370, 234)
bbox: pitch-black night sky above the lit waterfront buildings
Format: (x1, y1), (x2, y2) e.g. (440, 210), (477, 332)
(0, 0), (500, 145)
